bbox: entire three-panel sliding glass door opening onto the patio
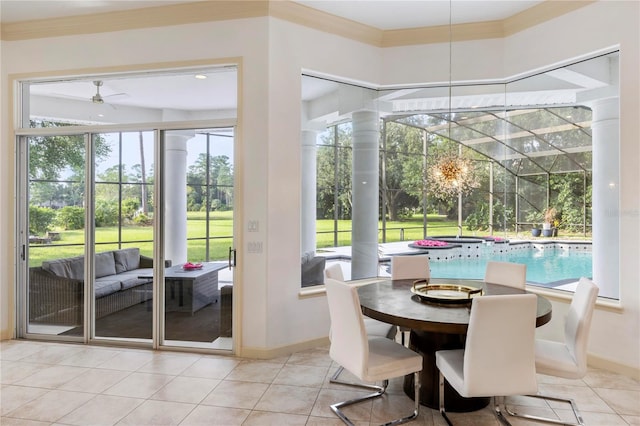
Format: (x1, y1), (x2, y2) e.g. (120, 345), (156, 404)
(19, 127), (235, 350)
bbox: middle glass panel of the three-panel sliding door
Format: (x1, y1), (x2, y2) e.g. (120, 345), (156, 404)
(93, 132), (154, 340)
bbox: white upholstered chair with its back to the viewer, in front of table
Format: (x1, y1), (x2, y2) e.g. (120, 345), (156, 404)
(436, 294), (538, 425)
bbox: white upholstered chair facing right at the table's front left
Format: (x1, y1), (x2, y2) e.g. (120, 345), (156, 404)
(325, 278), (422, 425)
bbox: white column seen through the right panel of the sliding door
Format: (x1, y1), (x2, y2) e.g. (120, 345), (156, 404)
(164, 132), (190, 265)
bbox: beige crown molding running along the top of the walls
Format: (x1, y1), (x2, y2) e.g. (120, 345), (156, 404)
(0, 0), (597, 47)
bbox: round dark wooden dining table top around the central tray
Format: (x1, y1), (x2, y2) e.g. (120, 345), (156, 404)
(358, 278), (551, 334)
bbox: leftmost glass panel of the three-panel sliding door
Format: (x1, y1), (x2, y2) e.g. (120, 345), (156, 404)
(25, 135), (85, 337)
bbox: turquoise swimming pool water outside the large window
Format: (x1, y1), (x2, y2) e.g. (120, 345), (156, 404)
(430, 249), (593, 286)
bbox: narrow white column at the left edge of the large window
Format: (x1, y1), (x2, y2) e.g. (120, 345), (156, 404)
(300, 130), (317, 253)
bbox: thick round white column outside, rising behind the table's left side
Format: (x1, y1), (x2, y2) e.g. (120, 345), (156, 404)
(351, 111), (380, 279)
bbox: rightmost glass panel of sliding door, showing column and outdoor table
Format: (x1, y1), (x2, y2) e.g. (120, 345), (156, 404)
(164, 128), (234, 350)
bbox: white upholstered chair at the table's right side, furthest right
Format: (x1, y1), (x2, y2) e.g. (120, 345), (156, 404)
(508, 277), (599, 425)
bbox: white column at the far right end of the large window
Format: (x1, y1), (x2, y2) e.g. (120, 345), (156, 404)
(589, 98), (620, 299)
